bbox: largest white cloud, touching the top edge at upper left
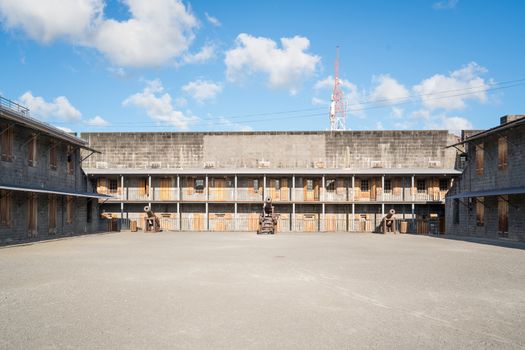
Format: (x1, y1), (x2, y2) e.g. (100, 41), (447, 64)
(0, 0), (198, 67)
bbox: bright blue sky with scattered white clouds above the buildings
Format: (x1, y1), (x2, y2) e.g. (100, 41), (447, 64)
(0, 0), (525, 133)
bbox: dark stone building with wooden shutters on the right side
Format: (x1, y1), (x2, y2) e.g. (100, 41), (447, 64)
(446, 115), (525, 241)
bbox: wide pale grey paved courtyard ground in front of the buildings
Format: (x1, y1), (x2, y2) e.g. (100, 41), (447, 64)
(0, 232), (525, 349)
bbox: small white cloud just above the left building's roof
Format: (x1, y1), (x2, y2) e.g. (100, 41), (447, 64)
(19, 91), (82, 121)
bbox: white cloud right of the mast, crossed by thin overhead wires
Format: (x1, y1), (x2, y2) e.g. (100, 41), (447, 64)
(413, 62), (491, 110)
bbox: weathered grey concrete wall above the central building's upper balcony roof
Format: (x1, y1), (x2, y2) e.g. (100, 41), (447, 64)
(81, 130), (458, 169)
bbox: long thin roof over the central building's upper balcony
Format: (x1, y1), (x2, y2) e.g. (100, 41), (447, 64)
(83, 168), (461, 175)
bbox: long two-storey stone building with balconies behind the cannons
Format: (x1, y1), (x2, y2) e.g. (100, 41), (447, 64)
(81, 131), (460, 233)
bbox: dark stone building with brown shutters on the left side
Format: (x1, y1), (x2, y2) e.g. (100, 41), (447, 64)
(0, 97), (104, 244)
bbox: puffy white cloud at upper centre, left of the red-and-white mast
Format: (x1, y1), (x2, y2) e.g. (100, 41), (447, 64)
(224, 33), (321, 93)
